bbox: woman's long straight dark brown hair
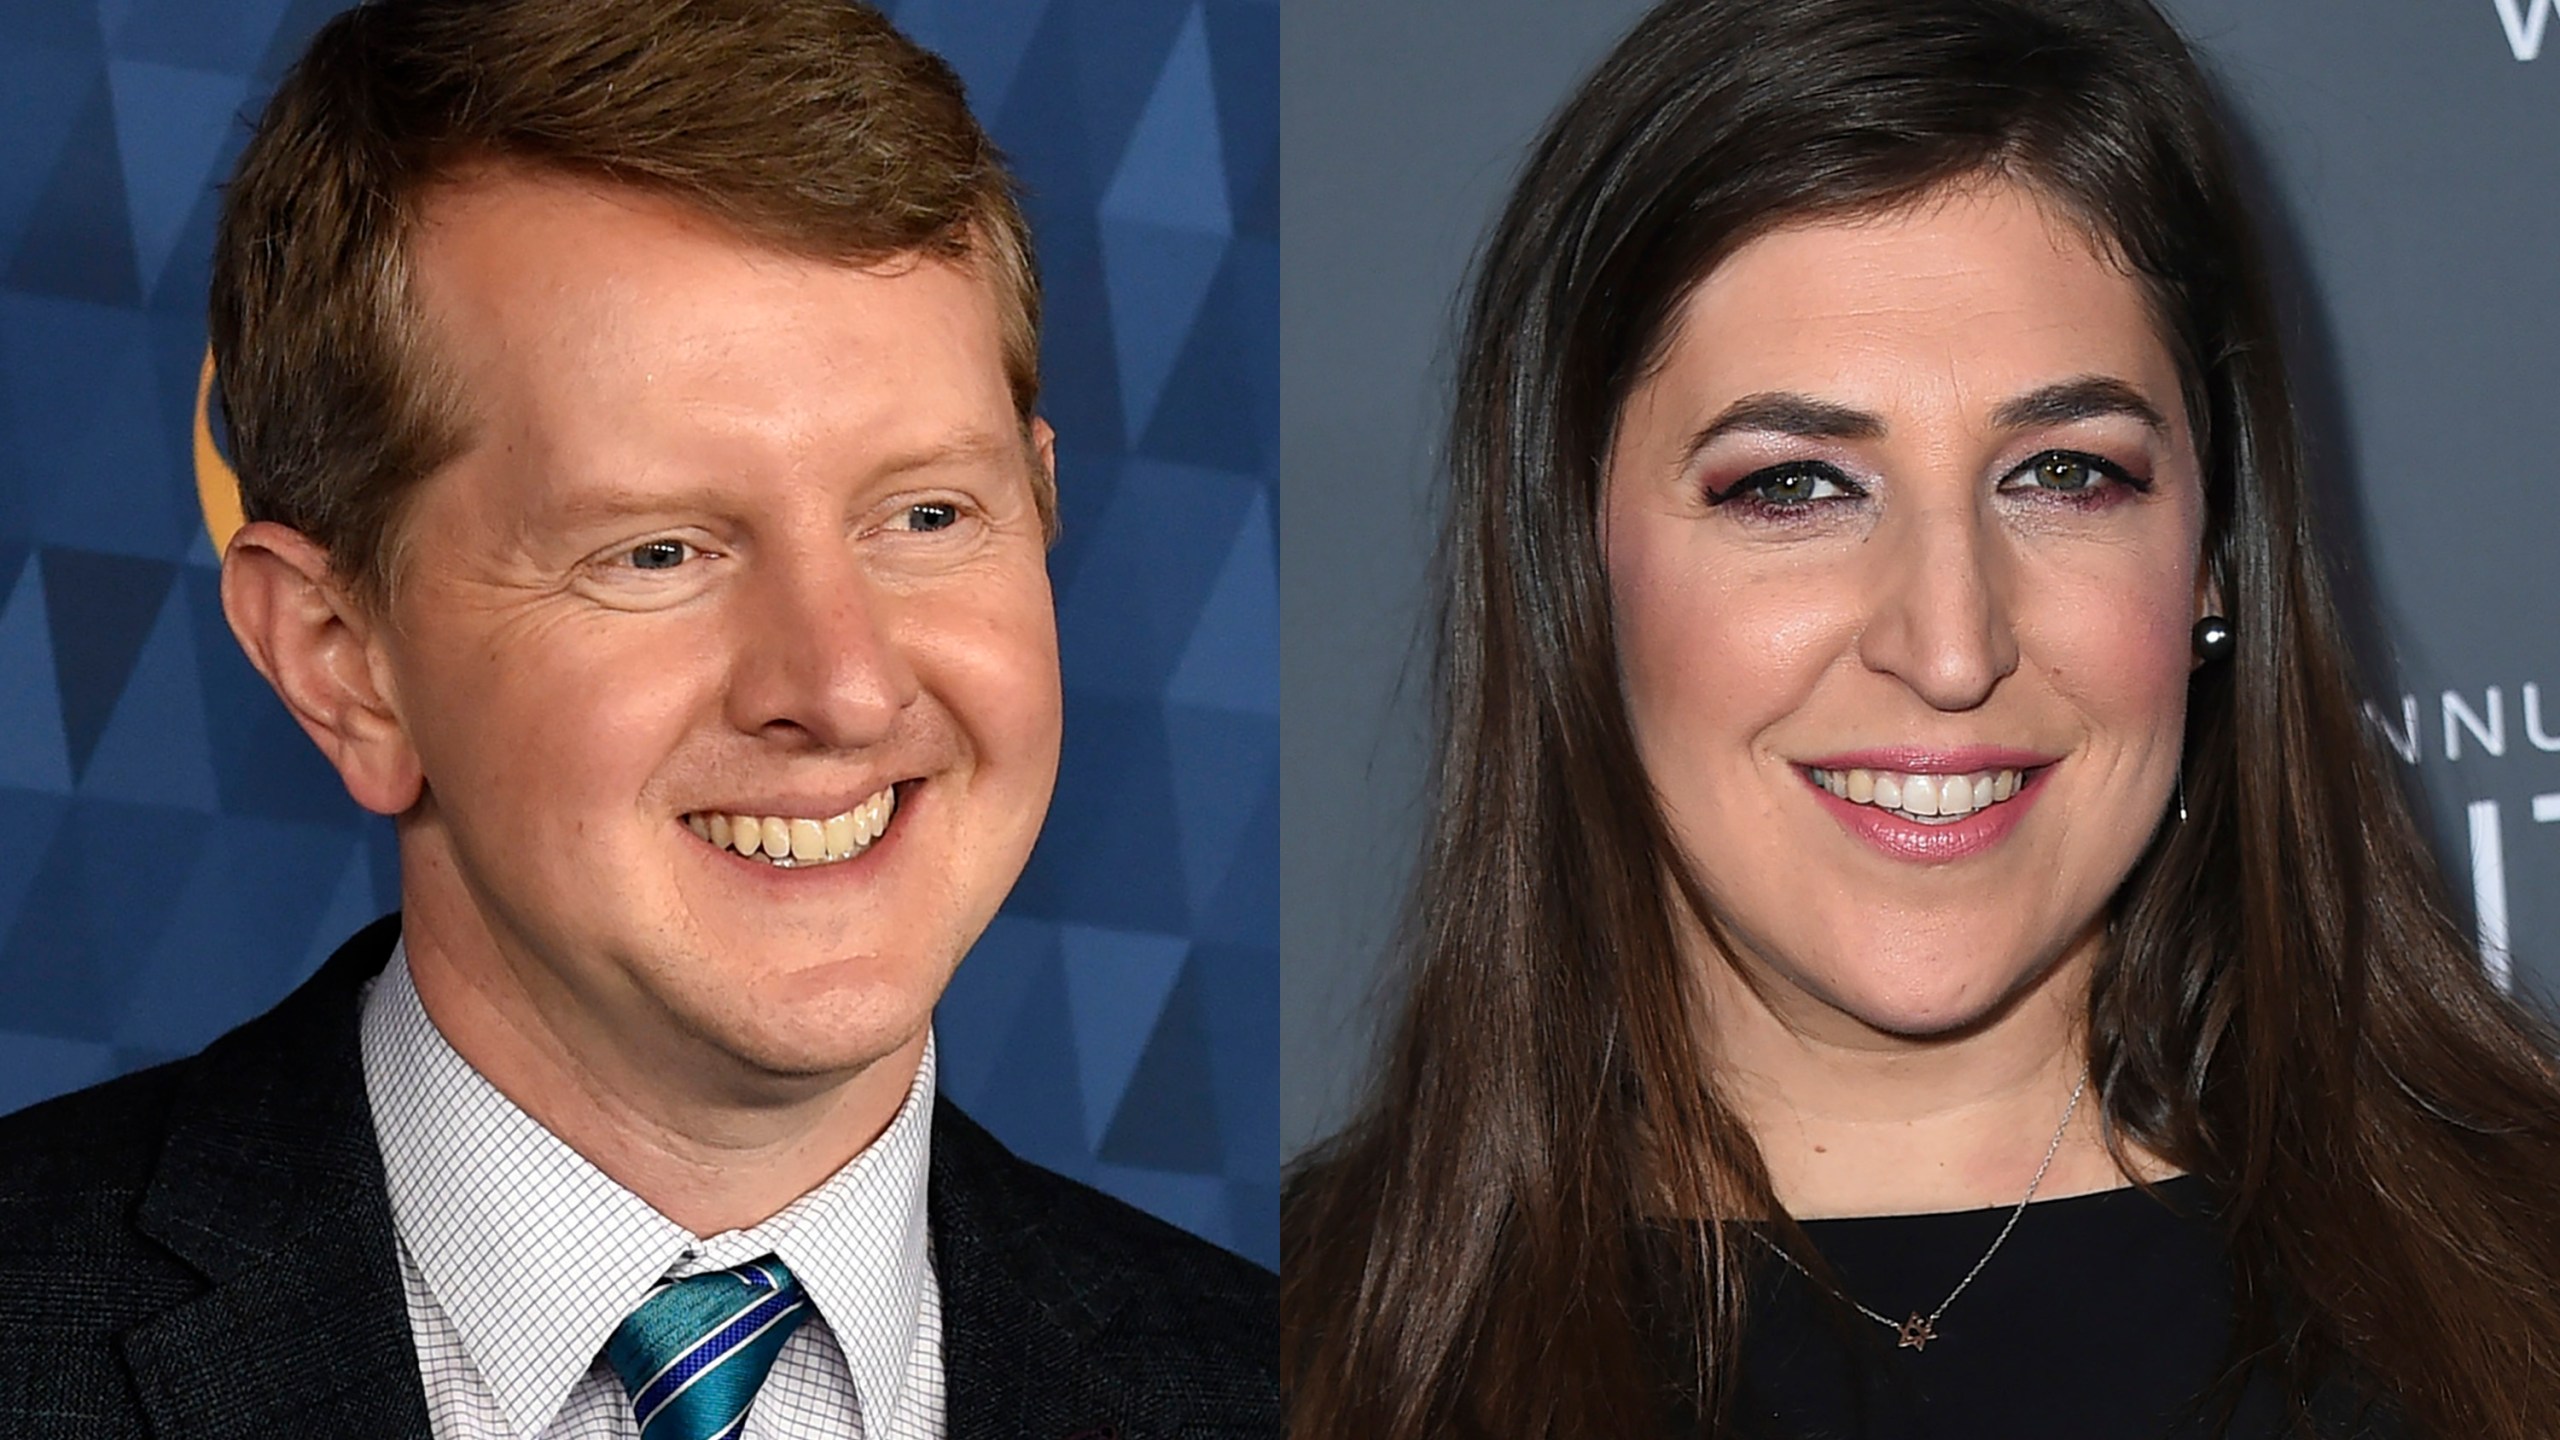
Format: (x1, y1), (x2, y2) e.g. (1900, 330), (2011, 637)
(1283, 0), (2560, 1440)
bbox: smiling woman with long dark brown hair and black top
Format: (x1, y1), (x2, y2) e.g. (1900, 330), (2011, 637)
(1283, 0), (2560, 1440)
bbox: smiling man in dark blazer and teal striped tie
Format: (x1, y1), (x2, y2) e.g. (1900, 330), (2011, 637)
(0, 0), (1280, 1440)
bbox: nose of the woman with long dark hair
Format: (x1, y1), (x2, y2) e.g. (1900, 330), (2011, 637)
(1859, 507), (2017, 710)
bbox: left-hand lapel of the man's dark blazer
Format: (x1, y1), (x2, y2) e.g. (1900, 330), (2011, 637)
(123, 920), (428, 1440)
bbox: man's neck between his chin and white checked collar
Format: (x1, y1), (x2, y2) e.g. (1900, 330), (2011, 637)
(404, 896), (927, 1219)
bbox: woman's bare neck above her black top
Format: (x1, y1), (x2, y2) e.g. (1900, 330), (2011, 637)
(1702, 945), (2171, 1220)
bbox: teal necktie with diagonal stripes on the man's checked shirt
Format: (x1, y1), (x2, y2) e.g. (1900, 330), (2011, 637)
(604, 1256), (809, 1440)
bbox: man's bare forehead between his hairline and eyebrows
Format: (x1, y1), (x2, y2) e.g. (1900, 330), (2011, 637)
(399, 169), (1021, 464)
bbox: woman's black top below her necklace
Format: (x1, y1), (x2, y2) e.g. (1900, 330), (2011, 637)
(1689, 1179), (2386, 1440)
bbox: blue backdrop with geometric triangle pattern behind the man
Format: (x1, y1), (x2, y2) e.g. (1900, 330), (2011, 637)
(0, 0), (1280, 1263)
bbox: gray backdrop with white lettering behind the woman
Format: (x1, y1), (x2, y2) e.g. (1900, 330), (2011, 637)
(1280, 0), (2560, 1150)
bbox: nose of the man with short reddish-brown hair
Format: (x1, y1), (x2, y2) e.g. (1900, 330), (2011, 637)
(730, 556), (919, 751)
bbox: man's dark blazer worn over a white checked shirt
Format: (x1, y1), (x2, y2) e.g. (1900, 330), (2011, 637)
(0, 917), (1280, 1440)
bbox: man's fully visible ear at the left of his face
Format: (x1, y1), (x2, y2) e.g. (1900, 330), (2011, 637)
(223, 520), (425, 815)
